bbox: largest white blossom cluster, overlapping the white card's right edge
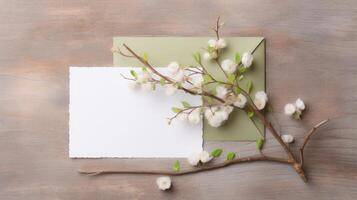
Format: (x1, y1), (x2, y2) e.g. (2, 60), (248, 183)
(205, 106), (233, 127)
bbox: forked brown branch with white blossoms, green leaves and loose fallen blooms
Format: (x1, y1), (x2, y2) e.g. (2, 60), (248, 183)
(96, 17), (328, 190)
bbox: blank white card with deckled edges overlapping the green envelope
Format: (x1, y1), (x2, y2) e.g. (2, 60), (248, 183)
(69, 67), (203, 158)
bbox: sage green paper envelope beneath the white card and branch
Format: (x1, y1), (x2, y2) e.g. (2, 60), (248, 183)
(113, 37), (265, 141)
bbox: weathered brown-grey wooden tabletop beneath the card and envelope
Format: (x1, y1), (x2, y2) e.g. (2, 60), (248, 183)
(0, 0), (357, 200)
